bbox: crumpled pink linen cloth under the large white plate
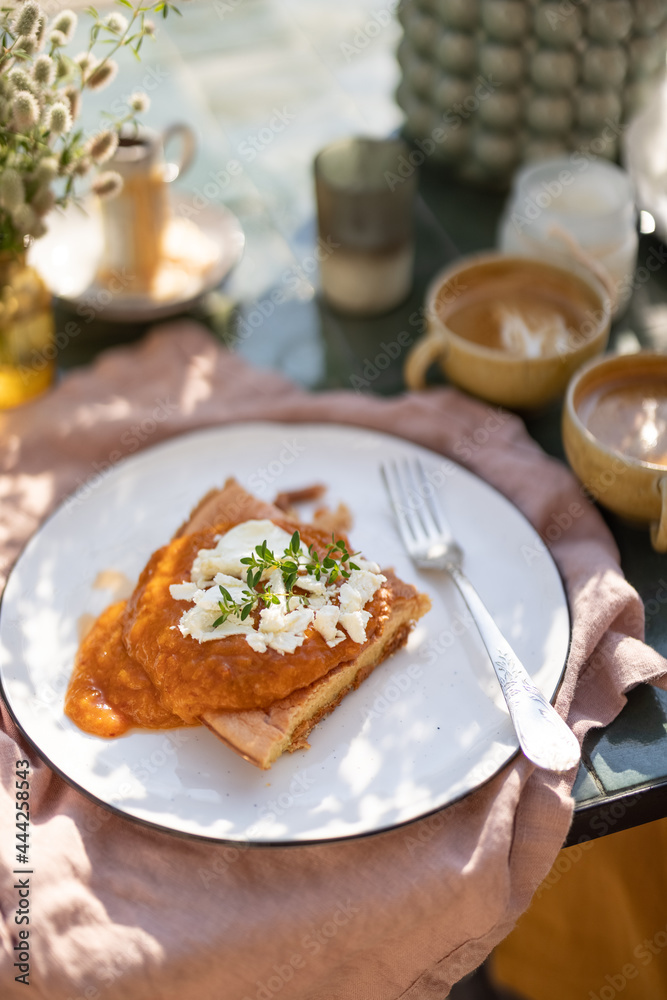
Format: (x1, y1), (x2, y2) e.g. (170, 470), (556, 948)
(0, 324), (667, 1000)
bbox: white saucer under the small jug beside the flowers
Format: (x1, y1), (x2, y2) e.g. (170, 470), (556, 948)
(29, 193), (245, 322)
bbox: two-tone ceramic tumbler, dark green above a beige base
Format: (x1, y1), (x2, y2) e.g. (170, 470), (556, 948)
(315, 138), (417, 316)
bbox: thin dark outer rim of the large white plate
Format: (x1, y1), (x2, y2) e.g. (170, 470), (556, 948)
(0, 419), (573, 850)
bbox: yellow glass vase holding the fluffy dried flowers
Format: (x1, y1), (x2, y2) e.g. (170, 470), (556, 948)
(0, 253), (56, 410)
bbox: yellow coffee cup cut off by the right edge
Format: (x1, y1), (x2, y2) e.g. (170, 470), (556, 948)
(563, 351), (667, 552)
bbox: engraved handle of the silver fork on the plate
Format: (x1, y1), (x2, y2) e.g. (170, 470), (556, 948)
(448, 566), (581, 771)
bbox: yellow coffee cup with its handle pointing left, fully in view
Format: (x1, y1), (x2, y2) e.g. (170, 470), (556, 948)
(405, 252), (611, 410)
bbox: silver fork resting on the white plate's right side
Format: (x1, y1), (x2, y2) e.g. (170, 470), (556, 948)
(380, 459), (581, 771)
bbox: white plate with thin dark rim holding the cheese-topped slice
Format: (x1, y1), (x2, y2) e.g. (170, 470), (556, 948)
(0, 424), (570, 844)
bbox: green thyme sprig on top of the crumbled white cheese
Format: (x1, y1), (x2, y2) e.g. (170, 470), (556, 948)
(212, 531), (359, 628)
